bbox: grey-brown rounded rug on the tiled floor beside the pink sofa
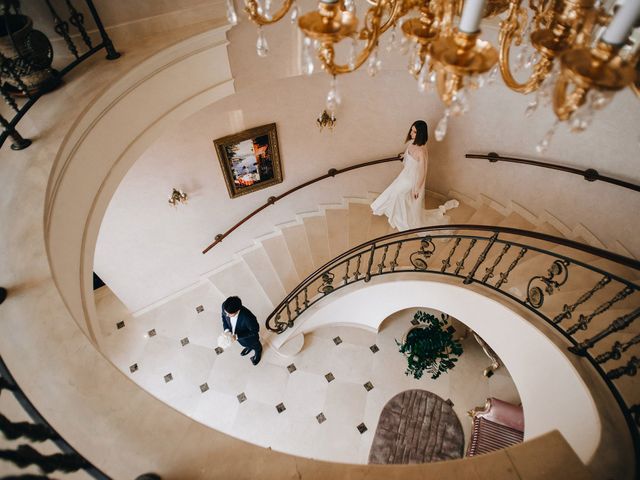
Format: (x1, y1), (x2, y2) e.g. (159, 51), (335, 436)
(369, 390), (464, 464)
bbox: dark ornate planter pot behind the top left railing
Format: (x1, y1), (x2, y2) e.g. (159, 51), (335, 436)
(0, 15), (60, 95)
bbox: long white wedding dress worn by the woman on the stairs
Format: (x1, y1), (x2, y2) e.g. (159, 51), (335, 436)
(371, 146), (459, 231)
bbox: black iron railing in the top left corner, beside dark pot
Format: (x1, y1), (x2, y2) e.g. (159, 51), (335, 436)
(0, 0), (120, 150)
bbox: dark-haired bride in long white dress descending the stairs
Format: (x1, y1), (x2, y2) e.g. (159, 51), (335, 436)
(371, 120), (458, 231)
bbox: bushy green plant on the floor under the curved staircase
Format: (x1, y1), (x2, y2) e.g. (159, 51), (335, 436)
(396, 310), (462, 380)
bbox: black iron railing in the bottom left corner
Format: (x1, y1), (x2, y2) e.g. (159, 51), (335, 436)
(0, 357), (110, 480)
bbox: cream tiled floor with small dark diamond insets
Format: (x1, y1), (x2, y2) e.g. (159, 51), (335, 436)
(103, 285), (519, 463)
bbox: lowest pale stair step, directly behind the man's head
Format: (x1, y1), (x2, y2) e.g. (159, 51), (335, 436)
(209, 262), (274, 321)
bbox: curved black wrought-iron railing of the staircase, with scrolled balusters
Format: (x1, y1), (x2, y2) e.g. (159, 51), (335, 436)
(265, 225), (640, 472)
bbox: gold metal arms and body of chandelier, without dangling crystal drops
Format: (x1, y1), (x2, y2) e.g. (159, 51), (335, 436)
(245, 0), (640, 121)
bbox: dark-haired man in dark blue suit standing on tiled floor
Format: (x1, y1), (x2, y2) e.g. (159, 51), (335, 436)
(222, 297), (262, 365)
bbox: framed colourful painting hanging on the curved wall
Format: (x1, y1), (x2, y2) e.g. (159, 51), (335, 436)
(213, 123), (282, 198)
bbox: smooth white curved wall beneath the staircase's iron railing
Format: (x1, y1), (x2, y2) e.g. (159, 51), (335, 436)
(273, 274), (602, 463)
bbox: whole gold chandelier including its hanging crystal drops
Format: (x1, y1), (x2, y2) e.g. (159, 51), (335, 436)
(227, 0), (640, 152)
